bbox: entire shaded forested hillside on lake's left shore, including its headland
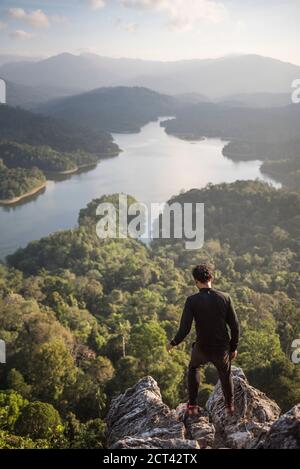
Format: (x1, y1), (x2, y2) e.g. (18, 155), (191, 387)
(0, 105), (120, 203)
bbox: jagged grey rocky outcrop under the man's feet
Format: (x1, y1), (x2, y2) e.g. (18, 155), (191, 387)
(107, 368), (300, 449)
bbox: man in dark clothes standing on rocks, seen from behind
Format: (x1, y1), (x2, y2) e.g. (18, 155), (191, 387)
(168, 264), (239, 415)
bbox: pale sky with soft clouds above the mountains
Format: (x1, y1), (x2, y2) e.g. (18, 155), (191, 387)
(0, 0), (300, 65)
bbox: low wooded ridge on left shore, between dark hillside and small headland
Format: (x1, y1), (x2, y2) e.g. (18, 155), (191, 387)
(0, 141), (99, 172)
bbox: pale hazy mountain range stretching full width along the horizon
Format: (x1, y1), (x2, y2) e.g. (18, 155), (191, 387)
(0, 53), (300, 98)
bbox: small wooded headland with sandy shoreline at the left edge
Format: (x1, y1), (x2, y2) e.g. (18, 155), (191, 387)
(0, 159), (46, 201)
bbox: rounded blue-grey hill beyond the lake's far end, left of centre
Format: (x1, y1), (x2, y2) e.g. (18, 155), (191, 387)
(38, 87), (181, 132)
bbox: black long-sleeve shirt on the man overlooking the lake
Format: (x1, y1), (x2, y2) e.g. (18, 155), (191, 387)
(171, 288), (239, 352)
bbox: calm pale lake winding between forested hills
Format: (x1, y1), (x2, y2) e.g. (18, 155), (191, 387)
(0, 121), (280, 259)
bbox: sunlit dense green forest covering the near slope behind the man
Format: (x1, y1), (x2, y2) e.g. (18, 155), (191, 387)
(0, 181), (300, 448)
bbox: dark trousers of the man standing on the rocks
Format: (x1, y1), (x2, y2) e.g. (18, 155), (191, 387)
(188, 342), (233, 406)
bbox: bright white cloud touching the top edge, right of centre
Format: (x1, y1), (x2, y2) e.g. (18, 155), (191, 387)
(121, 0), (227, 30)
